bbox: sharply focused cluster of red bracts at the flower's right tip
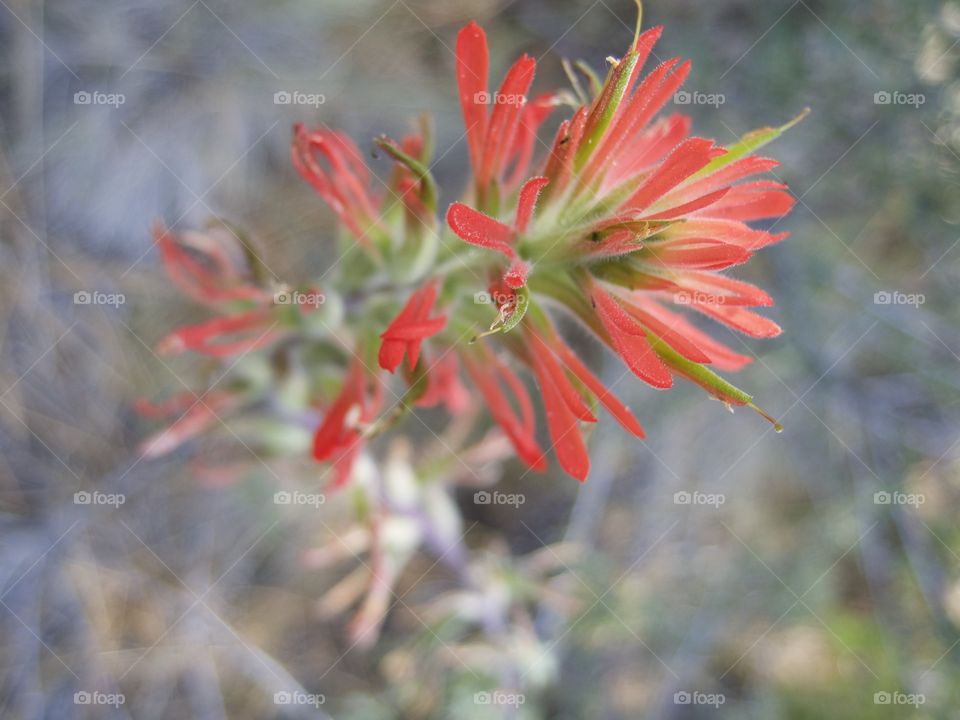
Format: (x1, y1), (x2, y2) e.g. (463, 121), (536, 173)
(447, 11), (793, 480)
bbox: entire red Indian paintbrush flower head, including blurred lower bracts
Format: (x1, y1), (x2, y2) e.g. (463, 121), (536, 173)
(144, 2), (802, 485)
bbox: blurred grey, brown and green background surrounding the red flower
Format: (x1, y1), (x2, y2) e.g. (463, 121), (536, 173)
(0, 0), (960, 720)
